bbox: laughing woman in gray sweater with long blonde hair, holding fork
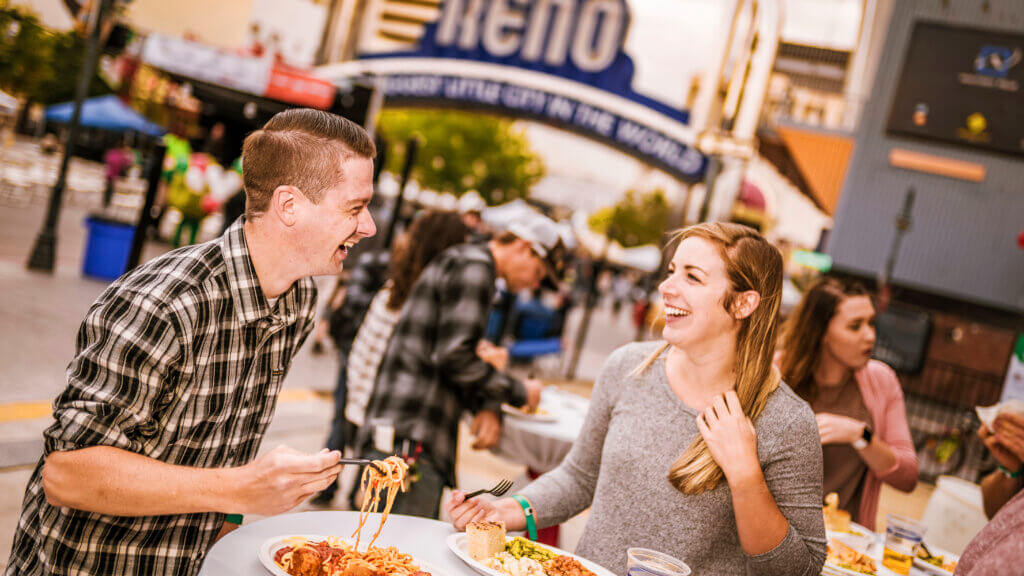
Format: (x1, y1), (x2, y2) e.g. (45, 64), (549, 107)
(446, 222), (825, 576)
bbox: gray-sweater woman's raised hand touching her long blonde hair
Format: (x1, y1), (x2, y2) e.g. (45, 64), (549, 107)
(697, 390), (762, 485)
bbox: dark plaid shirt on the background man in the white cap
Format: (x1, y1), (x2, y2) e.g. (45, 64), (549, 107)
(356, 244), (526, 486)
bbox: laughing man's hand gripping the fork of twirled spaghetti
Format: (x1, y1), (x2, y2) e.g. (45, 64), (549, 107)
(230, 446), (341, 516)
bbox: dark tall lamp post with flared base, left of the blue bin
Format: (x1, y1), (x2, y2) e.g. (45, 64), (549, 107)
(28, 0), (110, 273)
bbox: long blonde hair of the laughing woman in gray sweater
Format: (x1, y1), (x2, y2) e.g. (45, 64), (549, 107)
(633, 222), (782, 494)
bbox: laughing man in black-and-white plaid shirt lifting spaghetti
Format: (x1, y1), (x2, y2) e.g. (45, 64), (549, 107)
(6, 110), (376, 576)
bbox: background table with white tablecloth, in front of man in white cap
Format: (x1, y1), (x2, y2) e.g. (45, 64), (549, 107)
(494, 386), (590, 474)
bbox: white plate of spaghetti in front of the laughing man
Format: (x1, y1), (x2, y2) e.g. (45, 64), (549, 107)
(259, 534), (442, 576)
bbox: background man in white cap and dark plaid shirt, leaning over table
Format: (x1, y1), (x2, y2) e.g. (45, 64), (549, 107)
(355, 215), (564, 518)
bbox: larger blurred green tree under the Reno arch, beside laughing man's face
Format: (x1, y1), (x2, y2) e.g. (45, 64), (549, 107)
(378, 110), (545, 205)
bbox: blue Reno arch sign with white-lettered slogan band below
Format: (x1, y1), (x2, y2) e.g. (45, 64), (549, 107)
(319, 0), (707, 181)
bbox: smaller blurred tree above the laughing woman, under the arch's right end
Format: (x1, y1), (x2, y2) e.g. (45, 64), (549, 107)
(588, 189), (671, 248)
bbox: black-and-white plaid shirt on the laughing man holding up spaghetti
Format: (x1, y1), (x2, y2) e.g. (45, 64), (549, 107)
(6, 218), (316, 576)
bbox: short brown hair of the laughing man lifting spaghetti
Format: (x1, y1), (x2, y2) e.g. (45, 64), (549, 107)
(242, 108), (377, 217)
